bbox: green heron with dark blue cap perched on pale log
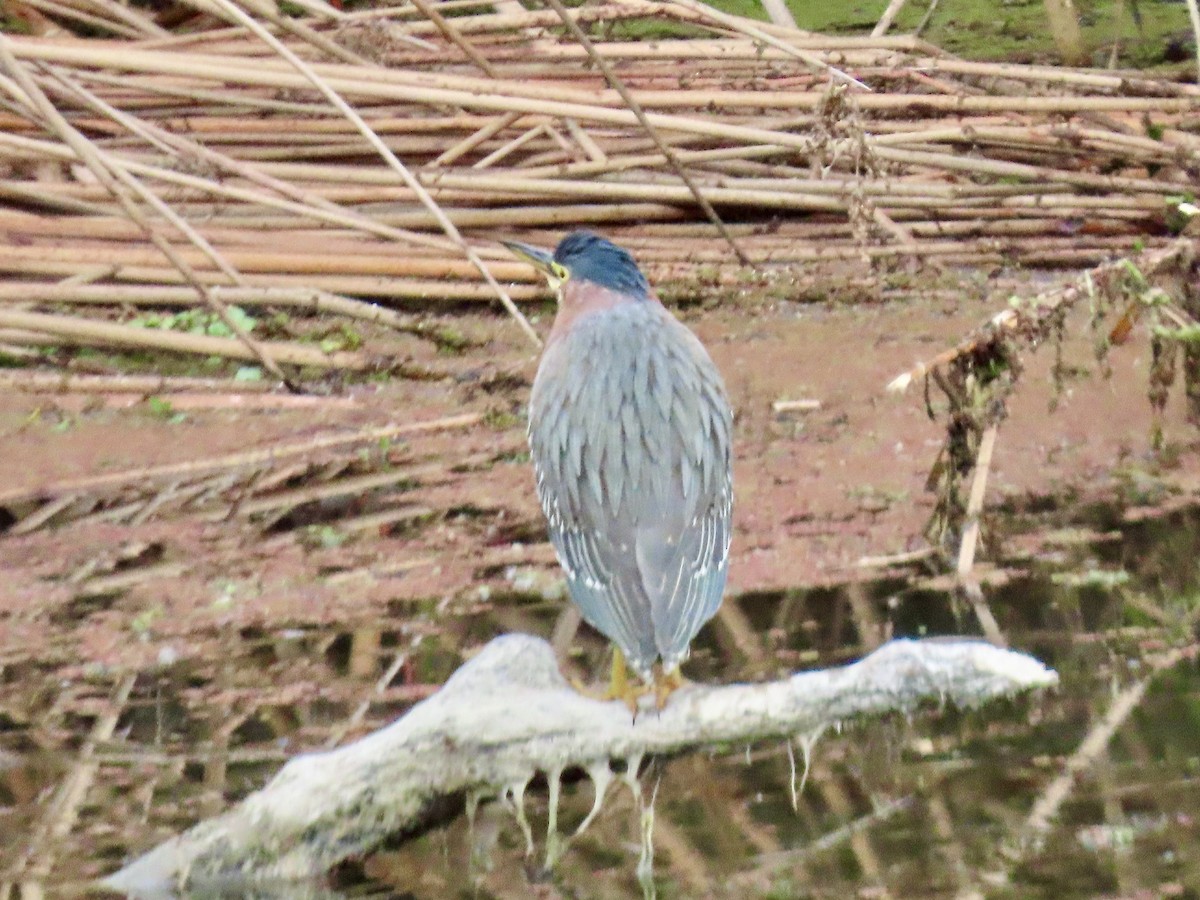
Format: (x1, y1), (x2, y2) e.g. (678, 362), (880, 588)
(505, 232), (733, 706)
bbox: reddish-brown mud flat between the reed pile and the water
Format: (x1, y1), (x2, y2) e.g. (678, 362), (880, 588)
(0, 271), (1200, 667)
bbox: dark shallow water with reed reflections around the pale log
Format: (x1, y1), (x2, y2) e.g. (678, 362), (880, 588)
(0, 506), (1200, 898)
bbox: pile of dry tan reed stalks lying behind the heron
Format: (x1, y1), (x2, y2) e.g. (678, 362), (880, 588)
(0, 0), (1200, 377)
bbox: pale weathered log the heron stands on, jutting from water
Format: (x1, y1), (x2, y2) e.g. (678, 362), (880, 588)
(106, 635), (1057, 895)
